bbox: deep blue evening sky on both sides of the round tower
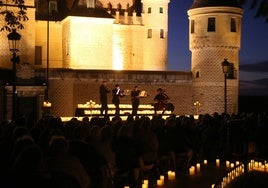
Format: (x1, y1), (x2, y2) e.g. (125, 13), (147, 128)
(168, 0), (268, 95)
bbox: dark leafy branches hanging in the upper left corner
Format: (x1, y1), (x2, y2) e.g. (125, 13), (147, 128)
(0, 0), (29, 32)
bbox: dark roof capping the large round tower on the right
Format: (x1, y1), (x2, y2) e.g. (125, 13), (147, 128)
(190, 0), (241, 9)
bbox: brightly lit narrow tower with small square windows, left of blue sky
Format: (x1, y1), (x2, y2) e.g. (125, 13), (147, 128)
(142, 0), (170, 70)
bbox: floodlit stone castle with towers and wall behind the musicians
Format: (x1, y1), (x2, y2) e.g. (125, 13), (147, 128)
(0, 0), (243, 118)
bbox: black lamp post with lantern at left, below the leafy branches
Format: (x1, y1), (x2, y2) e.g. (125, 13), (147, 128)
(7, 29), (21, 120)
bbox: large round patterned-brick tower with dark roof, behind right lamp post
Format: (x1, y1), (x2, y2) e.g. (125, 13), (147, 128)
(188, 0), (243, 113)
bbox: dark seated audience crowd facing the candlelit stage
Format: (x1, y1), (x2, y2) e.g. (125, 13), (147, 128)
(0, 113), (268, 188)
